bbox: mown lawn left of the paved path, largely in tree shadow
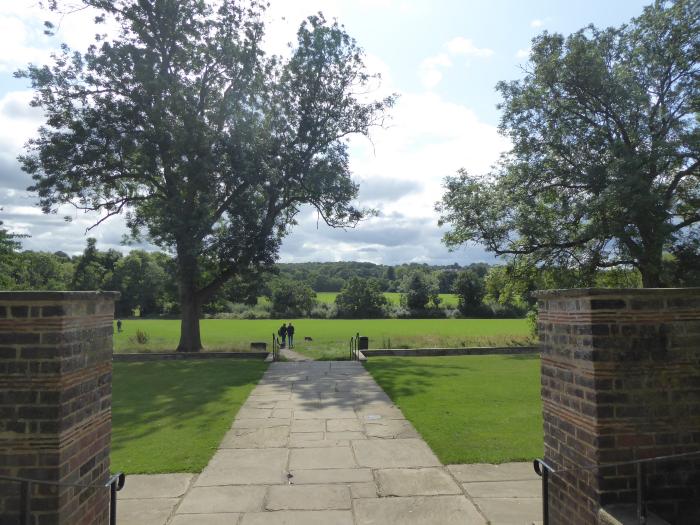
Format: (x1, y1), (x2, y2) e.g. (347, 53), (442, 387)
(112, 359), (267, 474)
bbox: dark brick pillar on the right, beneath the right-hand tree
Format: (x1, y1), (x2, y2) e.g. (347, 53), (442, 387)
(537, 288), (700, 525)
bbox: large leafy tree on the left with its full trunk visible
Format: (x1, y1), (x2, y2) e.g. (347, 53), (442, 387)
(18, 0), (393, 351)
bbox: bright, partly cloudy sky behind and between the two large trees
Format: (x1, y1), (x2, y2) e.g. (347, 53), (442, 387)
(0, 0), (650, 265)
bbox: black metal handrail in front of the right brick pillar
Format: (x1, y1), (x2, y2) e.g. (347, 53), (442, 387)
(533, 451), (700, 525)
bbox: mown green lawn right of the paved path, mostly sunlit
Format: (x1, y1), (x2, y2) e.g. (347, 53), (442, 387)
(365, 354), (543, 464)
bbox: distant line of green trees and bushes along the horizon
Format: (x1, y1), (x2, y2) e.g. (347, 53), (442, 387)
(0, 232), (700, 318)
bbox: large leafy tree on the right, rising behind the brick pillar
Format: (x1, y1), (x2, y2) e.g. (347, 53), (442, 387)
(437, 0), (700, 287)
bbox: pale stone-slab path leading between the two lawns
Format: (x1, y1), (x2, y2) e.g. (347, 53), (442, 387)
(118, 361), (541, 525)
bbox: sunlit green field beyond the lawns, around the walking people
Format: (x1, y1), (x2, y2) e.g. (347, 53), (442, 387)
(114, 319), (532, 359)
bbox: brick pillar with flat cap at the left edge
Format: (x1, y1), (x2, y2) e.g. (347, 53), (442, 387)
(0, 292), (119, 525)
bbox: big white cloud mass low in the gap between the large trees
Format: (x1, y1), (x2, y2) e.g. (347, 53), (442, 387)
(274, 93), (509, 264)
